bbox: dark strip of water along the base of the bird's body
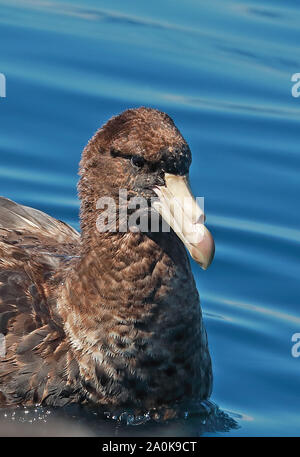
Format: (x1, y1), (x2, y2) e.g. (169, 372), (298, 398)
(0, 405), (238, 437)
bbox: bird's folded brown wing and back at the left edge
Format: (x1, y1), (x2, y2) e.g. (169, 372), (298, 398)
(0, 197), (80, 405)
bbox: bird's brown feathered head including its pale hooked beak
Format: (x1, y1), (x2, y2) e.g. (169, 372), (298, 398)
(79, 107), (214, 269)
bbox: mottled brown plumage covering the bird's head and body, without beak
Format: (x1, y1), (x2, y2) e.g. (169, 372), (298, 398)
(0, 108), (212, 412)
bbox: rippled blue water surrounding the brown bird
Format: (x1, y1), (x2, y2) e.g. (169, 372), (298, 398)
(0, 0), (300, 436)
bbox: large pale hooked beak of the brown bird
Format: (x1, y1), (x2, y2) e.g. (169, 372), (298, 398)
(153, 173), (215, 270)
